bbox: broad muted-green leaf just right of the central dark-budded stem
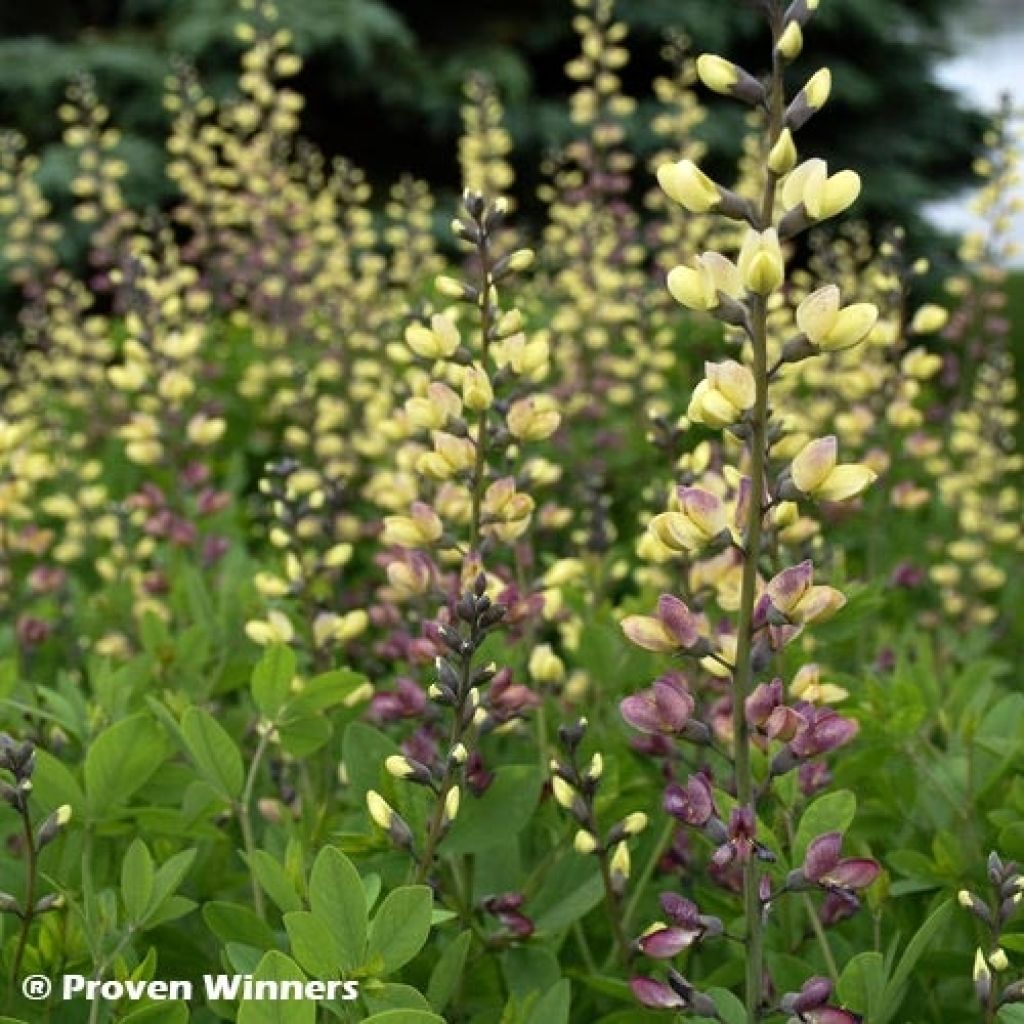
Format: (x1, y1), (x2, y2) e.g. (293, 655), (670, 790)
(441, 765), (541, 854)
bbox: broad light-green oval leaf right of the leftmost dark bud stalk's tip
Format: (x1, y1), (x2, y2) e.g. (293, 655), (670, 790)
(85, 715), (167, 819)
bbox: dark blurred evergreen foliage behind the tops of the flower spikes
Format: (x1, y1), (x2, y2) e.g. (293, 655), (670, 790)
(0, 0), (984, 238)
